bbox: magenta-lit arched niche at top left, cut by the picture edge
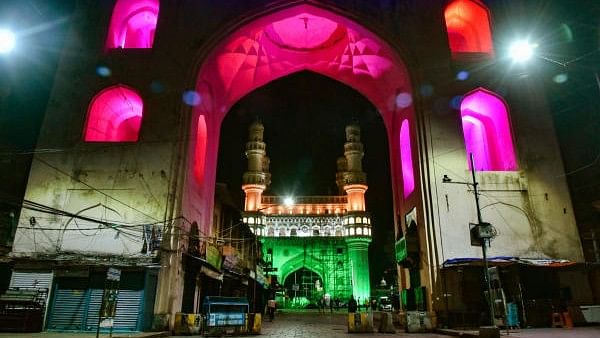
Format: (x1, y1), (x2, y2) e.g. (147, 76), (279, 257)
(106, 0), (159, 48)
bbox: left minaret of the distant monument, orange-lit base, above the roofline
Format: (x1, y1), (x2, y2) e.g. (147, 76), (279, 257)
(242, 121), (271, 211)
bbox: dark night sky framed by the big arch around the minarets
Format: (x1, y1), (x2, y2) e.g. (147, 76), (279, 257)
(217, 72), (394, 282)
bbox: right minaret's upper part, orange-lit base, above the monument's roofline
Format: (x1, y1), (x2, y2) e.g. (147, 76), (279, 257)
(336, 125), (368, 212)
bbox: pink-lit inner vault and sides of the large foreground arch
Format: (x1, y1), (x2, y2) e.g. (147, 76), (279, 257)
(182, 5), (419, 242)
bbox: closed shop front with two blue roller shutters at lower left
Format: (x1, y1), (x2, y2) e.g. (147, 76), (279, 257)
(47, 272), (148, 331)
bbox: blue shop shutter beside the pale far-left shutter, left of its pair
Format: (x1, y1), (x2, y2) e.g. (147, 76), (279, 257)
(47, 288), (88, 331)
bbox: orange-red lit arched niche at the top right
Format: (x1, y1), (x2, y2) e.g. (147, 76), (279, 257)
(444, 0), (494, 56)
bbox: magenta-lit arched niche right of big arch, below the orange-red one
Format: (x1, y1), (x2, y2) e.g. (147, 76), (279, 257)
(460, 88), (518, 171)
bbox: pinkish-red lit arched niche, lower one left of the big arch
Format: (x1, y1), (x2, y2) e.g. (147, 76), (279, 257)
(84, 85), (144, 142)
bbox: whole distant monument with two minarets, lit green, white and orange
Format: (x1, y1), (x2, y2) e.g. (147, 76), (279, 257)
(242, 122), (371, 302)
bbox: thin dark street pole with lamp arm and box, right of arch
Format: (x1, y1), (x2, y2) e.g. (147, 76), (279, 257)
(442, 153), (500, 337)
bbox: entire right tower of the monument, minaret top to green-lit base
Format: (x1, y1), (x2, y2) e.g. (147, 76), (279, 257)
(336, 125), (371, 301)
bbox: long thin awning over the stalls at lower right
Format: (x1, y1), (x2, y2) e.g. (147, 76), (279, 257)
(442, 256), (578, 268)
